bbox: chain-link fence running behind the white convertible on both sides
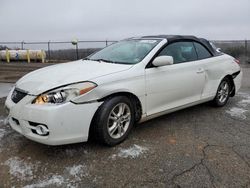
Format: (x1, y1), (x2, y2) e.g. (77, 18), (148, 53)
(0, 40), (250, 63)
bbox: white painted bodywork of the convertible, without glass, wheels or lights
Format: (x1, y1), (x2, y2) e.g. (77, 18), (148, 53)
(6, 39), (242, 145)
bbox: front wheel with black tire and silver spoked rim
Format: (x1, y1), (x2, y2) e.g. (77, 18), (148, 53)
(93, 96), (135, 146)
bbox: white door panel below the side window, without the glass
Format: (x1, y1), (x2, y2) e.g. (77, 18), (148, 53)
(146, 58), (205, 115)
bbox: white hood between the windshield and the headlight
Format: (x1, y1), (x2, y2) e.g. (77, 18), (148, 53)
(16, 60), (132, 95)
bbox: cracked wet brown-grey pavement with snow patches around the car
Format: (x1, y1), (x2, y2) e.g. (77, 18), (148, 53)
(0, 67), (250, 188)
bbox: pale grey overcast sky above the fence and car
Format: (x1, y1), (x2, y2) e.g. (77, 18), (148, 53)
(0, 0), (250, 41)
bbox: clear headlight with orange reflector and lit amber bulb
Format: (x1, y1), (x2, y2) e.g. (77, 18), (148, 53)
(33, 82), (97, 104)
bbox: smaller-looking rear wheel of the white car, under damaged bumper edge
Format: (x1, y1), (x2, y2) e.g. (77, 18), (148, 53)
(212, 77), (232, 107)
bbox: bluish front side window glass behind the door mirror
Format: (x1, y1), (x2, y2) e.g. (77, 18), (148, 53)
(158, 42), (197, 64)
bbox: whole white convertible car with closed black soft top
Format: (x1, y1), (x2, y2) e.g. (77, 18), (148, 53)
(5, 35), (242, 146)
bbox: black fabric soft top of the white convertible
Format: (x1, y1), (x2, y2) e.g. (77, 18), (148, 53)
(141, 35), (221, 56)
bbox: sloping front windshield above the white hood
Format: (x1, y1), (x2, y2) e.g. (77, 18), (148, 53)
(88, 39), (160, 64)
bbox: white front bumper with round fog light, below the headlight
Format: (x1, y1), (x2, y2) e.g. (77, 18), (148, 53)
(5, 92), (101, 145)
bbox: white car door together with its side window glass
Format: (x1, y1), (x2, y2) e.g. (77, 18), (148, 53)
(145, 41), (205, 115)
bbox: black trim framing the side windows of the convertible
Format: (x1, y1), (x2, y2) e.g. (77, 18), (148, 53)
(145, 39), (215, 69)
